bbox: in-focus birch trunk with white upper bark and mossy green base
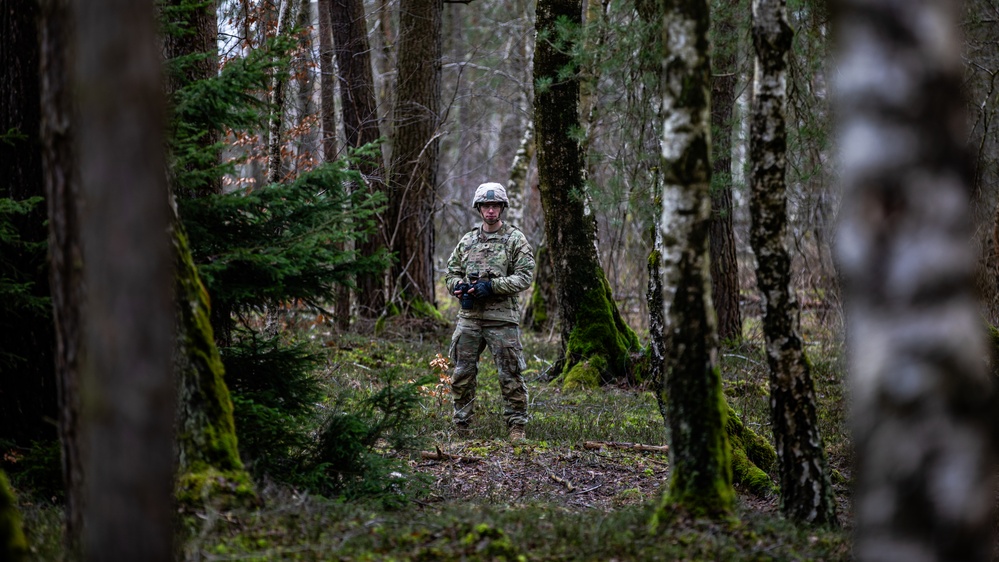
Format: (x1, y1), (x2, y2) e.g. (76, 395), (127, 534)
(658, 0), (735, 515)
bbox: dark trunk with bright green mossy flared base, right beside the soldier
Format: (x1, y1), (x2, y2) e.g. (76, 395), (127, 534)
(534, 0), (639, 388)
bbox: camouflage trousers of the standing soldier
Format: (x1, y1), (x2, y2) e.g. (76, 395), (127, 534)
(450, 318), (527, 426)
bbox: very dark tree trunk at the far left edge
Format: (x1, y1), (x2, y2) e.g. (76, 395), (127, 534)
(0, 0), (58, 445)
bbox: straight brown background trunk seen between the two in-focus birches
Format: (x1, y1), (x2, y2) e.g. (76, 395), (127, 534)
(710, 2), (742, 341)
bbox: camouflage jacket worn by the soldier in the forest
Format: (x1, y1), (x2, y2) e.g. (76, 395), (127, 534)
(444, 224), (534, 324)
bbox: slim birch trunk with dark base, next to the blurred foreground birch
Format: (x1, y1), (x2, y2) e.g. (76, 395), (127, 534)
(749, 0), (837, 525)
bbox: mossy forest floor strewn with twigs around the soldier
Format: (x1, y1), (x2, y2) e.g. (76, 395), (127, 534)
(13, 316), (852, 561)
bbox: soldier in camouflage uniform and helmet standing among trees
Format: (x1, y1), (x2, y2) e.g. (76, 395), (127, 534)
(444, 183), (534, 441)
